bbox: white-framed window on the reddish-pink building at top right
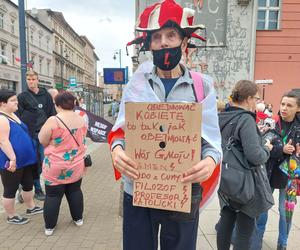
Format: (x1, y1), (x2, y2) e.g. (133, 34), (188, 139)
(256, 0), (282, 31)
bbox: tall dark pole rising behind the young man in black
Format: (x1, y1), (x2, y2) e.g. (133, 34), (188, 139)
(19, 0), (27, 92)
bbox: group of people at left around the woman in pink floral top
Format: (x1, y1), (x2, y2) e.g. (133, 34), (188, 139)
(0, 70), (87, 236)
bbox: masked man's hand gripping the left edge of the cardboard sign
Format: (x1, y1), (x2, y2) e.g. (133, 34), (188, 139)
(111, 146), (139, 180)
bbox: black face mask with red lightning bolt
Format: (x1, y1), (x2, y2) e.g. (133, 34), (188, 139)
(152, 45), (182, 70)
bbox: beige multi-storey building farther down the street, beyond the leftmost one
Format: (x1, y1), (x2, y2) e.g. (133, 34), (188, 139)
(31, 9), (103, 115)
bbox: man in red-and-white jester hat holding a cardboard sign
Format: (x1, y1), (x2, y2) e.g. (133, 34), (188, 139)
(109, 0), (221, 250)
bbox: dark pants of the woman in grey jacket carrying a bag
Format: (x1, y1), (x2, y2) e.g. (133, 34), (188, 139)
(217, 207), (255, 250)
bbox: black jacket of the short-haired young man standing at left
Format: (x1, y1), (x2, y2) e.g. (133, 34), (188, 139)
(16, 88), (56, 138)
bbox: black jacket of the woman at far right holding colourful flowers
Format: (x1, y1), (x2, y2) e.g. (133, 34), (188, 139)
(266, 112), (300, 189)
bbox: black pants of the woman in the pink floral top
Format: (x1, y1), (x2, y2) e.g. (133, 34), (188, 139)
(44, 179), (83, 229)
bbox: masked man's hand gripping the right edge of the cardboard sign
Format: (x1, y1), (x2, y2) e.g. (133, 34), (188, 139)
(182, 157), (216, 183)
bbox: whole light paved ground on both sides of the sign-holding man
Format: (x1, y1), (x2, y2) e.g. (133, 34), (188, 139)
(0, 143), (300, 250)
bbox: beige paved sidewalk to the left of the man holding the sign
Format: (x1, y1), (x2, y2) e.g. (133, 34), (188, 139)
(0, 144), (121, 250)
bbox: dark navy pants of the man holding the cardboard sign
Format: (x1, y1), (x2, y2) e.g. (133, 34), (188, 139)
(123, 185), (202, 250)
